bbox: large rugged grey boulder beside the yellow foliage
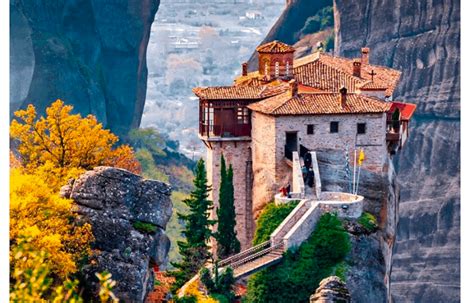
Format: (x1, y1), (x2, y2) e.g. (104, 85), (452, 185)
(61, 167), (172, 302)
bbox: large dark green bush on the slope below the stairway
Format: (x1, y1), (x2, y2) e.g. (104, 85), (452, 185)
(243, 214), (350, 303)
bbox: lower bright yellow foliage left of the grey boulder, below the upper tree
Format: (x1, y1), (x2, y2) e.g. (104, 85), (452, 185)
(10, 169), (93, 279)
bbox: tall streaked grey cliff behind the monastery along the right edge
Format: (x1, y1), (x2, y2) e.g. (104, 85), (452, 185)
(335, 0), (460, 302)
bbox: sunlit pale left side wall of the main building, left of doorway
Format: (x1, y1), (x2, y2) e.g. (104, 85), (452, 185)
(248, 112), (278, 217)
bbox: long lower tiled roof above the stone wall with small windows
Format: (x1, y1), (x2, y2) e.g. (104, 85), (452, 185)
(248, 92), (392, 115)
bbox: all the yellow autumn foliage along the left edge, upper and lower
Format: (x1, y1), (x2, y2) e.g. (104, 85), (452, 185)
(10, 100), (141, 302)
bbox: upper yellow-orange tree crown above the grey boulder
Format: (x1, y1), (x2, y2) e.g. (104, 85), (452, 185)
(10, 100), (140, 179)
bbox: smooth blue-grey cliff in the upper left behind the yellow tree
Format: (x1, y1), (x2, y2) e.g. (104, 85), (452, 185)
(10, 0), (159, 134)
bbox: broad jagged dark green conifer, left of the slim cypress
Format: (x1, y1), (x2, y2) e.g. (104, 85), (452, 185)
(170, 159), (215, 291)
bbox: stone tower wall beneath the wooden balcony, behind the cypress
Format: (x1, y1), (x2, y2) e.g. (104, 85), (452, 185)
(206, 141), (254, 249)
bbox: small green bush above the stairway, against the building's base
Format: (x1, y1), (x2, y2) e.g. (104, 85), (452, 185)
(253, 201), (298, 245)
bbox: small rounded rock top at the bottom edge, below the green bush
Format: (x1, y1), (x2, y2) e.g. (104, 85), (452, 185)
(309, 276), (351, 303)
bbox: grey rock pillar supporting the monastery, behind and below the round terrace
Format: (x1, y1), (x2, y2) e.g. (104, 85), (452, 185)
(317, 149), (400, 302)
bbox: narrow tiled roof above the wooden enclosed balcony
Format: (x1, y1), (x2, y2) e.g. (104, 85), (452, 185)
(193, 83), (288, 100)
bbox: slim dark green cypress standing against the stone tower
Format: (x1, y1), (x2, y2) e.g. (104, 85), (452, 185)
(215, 155), (240, 259)
